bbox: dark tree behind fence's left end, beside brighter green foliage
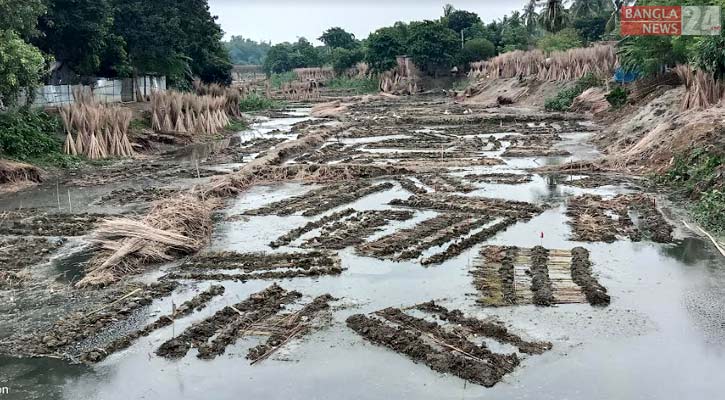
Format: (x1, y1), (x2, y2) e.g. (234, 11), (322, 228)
(35, 0), (113, 75)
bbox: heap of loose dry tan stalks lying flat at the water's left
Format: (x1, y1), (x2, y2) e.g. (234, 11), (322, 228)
(76, 194), (219, 287)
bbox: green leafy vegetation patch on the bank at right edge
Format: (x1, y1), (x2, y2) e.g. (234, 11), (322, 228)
(654, 149), (725, 237)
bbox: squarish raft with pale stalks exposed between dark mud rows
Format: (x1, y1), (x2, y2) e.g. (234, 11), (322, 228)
(471, 246), (610, 306)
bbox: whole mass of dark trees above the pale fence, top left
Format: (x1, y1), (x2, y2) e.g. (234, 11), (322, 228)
(0, 0), (231, 105)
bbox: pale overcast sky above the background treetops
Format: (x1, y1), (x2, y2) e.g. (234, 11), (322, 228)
(206, 0), (526, 44)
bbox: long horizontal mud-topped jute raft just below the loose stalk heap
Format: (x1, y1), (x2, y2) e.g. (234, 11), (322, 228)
(163, 251), (343, 282)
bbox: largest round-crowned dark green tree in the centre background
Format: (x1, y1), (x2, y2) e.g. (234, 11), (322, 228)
(407, 21), (460, 74)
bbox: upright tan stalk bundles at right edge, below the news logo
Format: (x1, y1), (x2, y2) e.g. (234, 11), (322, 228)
(675, 65), (725, 110)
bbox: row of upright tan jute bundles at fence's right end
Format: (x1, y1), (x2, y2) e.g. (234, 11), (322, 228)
(151, 91), (230, 135)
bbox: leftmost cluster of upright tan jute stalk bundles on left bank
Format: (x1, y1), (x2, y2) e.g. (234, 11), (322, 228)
(60, 101), (134, 160)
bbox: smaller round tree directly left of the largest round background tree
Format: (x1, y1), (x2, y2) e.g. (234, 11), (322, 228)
(365, 23), (408, 72)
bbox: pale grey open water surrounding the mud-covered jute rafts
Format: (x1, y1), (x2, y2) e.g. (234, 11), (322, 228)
(0, 112), (725, 400)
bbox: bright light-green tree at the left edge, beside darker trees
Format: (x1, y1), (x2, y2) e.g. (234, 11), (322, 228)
(0, 30), (45, 108)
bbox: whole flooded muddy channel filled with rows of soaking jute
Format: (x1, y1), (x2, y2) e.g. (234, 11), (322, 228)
(0, 94), (725, 399)
